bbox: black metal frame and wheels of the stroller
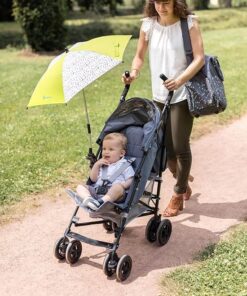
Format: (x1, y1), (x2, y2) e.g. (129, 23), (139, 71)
(54, 77), (172, 281)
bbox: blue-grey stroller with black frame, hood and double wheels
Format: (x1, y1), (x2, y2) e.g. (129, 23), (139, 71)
(54, 76), (172, 281)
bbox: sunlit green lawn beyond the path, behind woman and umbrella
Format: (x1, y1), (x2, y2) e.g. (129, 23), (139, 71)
(0, 13), (247, 205)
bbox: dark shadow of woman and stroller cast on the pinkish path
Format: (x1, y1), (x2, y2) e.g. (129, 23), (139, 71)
(71, 194), (247, 284)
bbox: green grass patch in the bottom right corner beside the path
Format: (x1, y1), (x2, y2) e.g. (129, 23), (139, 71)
(164, 224), (247, 296)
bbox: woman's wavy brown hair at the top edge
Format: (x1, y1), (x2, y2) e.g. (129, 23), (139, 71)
(144, 0), (192, 18)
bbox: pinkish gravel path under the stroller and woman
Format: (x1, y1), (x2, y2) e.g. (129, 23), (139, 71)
(0, 116), (247, 296)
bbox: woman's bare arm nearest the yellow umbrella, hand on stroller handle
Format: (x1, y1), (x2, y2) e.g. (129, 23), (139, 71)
(122, 30), (148, 84)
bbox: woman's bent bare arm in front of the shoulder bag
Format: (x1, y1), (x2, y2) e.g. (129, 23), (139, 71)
(164, 21), (204, 90)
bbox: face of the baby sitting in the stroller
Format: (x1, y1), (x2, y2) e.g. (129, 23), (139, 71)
(102, 139), (125, 164)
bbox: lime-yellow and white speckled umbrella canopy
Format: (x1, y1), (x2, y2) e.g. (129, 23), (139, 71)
(27, 35), (131, 107)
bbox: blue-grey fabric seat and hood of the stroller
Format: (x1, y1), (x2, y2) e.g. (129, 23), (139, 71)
(90, 98), (166, 224)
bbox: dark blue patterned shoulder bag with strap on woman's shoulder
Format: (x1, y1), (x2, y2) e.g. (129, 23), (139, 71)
(181, 18), (227, 117)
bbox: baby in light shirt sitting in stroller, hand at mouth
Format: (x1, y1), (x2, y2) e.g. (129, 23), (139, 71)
(76, 133), (135, 211)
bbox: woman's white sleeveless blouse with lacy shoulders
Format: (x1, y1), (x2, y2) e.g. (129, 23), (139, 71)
(141, 15), (193, 104)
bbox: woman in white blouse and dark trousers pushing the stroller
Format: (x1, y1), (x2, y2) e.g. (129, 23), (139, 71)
(122, 0), (204, 217)
